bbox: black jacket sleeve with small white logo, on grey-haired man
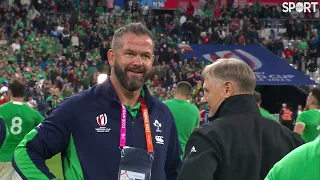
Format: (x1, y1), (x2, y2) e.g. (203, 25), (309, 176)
(177, 128), (222, 180)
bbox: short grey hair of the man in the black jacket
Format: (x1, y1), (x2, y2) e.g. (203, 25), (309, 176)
(202, 58), (256, 94)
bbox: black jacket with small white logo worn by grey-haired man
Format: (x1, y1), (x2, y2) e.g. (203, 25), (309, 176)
(178, 95), (303, 180)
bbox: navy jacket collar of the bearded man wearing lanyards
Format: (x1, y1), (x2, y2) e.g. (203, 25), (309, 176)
(94, 79), (155, 110)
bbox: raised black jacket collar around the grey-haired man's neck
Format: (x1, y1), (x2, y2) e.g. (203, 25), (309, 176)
(209, 94), (259, 121)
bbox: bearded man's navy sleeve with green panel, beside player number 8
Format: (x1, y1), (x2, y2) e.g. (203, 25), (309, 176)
(12, 100), (76, 180)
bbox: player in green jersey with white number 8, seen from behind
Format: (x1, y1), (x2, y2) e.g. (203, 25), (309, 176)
(0, 79), (44, 180)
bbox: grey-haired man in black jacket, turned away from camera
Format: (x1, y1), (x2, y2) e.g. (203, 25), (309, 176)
(177, 59), (303, 180)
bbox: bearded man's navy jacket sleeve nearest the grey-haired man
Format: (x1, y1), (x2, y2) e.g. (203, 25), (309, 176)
(165, 112), (182, 180)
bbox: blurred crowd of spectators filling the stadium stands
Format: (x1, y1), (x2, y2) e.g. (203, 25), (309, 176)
(0, 0), (320, 114)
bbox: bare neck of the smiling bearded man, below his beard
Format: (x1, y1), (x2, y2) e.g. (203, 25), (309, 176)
(110, 73), (142, 108)
